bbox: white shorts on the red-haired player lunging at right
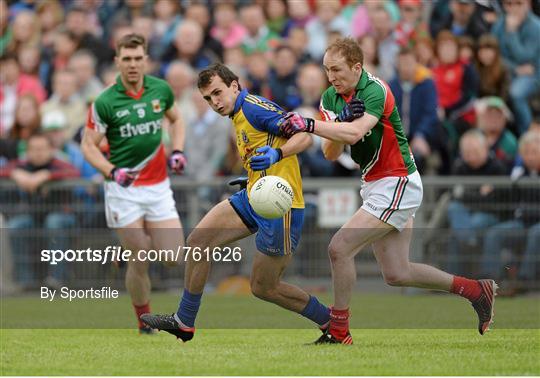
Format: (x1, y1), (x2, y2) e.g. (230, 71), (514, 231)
(360, 171), (424, 231)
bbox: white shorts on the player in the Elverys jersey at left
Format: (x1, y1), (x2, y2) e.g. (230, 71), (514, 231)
(104, 178), (179, 228)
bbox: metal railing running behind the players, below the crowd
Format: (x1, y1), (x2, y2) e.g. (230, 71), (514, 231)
(0, 176), (540, 288)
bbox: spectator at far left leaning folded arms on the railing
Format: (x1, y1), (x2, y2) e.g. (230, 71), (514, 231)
(0, 134), (79, 286)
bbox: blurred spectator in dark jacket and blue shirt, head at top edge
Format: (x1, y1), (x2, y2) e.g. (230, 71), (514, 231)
(430, 0), (489, 40)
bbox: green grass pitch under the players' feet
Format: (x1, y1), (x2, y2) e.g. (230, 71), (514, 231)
(0, 294), (540, 376)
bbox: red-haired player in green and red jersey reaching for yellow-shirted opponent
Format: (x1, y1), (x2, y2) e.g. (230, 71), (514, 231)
(281, 38), (497, 344)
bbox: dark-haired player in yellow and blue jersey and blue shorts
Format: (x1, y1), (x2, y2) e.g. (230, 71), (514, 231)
(141, 63), (330, 341)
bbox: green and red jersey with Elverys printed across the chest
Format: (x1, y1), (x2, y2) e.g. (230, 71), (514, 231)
(86, 75), (174, 186)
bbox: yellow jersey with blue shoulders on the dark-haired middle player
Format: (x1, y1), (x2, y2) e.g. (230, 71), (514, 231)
(231, 89), (304, 209)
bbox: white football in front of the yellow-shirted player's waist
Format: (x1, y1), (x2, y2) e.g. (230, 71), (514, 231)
(249, 176), (294, 219)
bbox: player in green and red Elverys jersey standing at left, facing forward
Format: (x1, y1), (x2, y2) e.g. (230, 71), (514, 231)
(82, 34), (186, 332)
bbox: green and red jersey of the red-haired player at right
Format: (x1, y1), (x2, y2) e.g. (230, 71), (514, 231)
(319, 70), (416, 181)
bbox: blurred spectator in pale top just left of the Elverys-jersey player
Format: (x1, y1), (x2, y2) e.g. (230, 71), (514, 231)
(41, 70), (87, 139)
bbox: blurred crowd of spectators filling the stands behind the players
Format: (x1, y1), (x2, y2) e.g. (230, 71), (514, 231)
(0, 0), (540, 290)
